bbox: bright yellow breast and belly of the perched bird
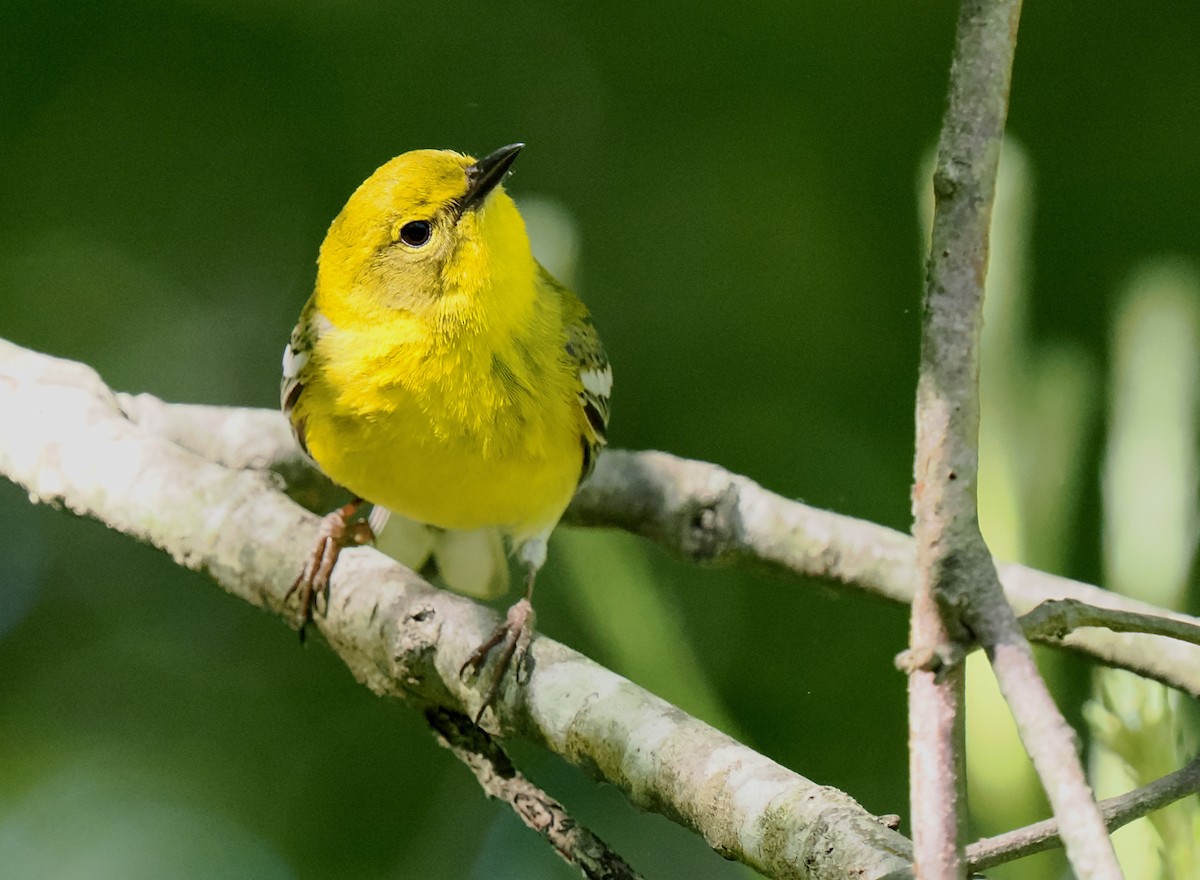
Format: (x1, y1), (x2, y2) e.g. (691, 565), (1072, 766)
(293, 304), (583, 539)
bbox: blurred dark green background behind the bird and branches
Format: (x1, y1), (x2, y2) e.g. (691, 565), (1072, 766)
(0, 0), (1200, 879)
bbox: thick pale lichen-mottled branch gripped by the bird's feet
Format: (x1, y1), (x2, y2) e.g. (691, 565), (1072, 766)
(0, 341), (910, 880)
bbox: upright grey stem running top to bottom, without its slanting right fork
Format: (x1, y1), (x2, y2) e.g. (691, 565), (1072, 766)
(901, 0), (1020, 880)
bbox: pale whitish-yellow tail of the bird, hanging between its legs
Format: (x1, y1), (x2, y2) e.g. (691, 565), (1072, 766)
(368, 507), (509, 599)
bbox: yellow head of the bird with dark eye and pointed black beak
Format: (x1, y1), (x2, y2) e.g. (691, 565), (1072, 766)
(317, 144), (536, 317)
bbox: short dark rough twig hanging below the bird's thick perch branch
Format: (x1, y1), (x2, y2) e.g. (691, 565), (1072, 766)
(425, 708), (641, 880)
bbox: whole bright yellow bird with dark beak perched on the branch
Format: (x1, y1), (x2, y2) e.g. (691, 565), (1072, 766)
(281, 144), (612, 722)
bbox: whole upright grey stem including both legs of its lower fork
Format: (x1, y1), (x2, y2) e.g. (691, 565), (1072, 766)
(908, 0), (1121, 880)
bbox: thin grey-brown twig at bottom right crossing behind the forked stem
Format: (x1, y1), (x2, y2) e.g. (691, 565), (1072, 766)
(967, 758), (1200, 870)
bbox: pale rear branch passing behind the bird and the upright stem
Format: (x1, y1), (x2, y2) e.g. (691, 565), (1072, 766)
(116, 394), (1200, 698)
